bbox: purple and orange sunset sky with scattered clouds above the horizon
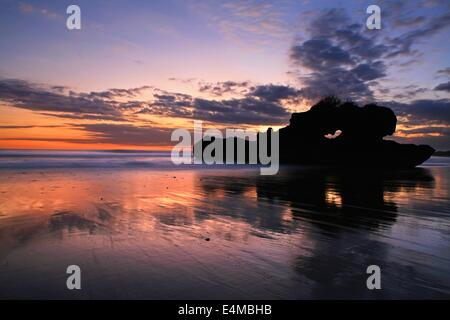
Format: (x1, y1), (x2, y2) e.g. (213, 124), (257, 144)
(0, 0), (450, 150)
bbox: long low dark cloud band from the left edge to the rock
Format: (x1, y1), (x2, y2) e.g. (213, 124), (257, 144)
(0, 80), (290, 124)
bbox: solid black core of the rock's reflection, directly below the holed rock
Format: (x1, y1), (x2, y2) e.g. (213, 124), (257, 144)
(257, 168), (434, 233)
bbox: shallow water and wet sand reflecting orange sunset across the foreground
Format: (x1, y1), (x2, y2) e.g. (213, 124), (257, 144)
(0, 153), (450, 299)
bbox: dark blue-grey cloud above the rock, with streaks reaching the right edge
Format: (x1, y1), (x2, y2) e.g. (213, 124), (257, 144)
(290, 6), (450, 100)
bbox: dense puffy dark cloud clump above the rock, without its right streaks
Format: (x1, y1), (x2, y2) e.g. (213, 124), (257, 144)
(290, 9), (388, 100)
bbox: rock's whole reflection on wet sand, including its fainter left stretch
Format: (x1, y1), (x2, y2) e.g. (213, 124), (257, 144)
(199, 167), (434, 234)
